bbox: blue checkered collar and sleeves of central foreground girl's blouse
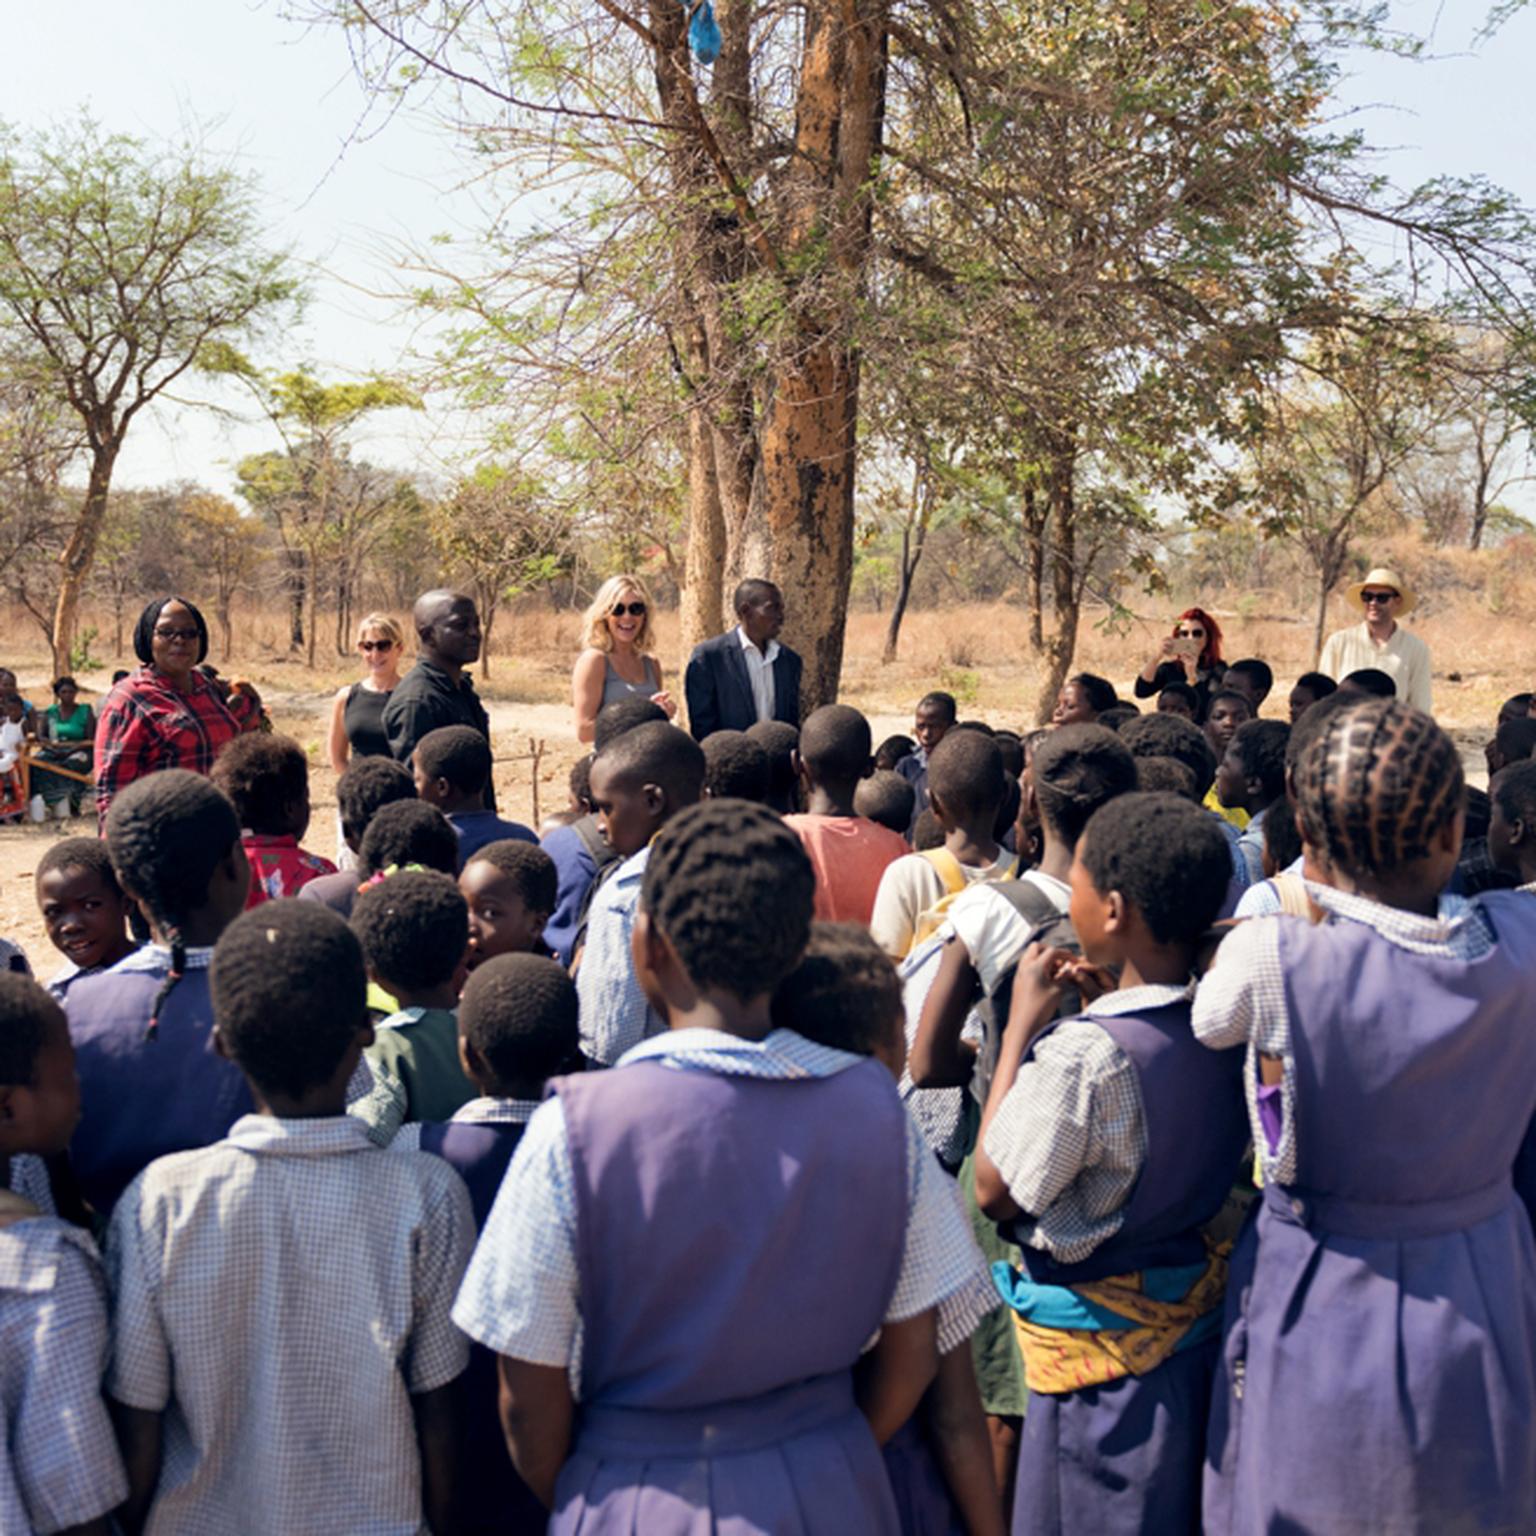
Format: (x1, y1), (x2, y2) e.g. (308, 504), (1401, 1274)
(453, 1029), (995, 1384)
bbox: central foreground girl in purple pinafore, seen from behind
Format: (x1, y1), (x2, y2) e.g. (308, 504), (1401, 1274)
(453, 798), (975, 1536)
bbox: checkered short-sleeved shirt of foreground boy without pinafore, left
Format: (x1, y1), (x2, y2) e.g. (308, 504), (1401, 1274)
(106, 1115), (475, 1536)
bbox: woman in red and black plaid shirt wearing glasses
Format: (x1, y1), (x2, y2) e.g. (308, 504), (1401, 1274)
(95, 598), (240, 825)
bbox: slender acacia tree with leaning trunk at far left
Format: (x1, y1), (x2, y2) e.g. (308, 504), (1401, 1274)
(0, 121), (298, 665)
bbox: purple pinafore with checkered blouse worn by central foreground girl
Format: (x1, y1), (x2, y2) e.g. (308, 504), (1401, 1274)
(455, 1031), (977, 1536)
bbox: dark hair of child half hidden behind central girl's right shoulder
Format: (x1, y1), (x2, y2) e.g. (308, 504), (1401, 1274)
(773, 923), (905, 1055)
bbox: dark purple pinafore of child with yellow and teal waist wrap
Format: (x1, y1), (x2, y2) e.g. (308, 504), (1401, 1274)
(1003, 988), (1247, 1536)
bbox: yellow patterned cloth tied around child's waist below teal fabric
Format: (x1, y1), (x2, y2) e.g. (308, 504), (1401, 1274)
(1014, 1244), (1229, 1393)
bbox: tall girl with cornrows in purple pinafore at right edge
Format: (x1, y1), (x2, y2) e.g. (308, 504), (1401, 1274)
(1193, 699), (1536, 1536)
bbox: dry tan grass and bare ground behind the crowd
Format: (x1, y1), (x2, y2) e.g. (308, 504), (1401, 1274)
(0, 565), (1536, 974)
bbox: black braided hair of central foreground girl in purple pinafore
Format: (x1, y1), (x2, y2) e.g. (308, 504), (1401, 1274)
(641, 800), (816, 997)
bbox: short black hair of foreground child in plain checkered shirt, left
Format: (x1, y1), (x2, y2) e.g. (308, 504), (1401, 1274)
(209, 902), (367, 1097)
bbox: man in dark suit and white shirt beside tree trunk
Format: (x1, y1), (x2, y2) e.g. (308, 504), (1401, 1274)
(684, 578), (800, 742)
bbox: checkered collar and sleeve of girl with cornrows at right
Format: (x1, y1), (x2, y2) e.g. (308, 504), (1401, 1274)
(1190, 882), (1495, 1184)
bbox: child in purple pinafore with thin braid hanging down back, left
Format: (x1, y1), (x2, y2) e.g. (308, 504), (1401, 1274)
(65, 768), (250, 1213)
